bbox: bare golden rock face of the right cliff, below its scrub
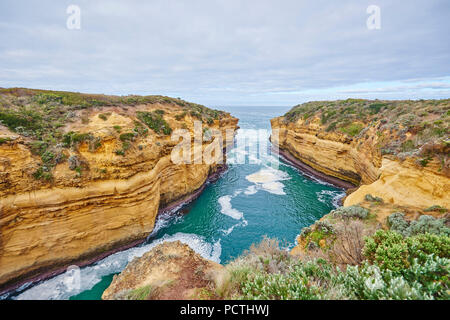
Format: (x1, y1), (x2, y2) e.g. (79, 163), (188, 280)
(272, 117), (450, 208)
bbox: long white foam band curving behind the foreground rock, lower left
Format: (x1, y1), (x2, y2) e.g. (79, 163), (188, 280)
(16, 232), (222, 300)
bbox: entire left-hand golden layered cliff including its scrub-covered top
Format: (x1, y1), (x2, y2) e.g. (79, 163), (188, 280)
(0, 89), (238, 291)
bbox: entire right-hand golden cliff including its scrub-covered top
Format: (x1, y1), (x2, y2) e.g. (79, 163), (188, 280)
(272, 99), (450, 208)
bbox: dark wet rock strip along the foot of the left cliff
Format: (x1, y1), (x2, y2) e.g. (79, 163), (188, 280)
(0, 164), (228, 300)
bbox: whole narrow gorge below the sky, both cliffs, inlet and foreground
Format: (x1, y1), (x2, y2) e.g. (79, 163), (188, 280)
(0, 89), (450, 300)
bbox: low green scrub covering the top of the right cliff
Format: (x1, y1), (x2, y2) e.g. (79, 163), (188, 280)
(284, 99), (450, 168)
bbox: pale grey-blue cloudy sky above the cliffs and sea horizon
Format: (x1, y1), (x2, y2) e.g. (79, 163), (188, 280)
(0, 0), (450, 106)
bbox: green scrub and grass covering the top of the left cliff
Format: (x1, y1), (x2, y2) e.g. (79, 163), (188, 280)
(0, 88), (226, 181)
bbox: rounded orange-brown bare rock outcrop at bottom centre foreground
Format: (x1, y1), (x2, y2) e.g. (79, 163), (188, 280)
(102, 241), (225, 300)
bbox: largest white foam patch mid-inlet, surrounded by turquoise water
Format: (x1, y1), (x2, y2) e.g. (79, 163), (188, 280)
(245, 167), (290, 195)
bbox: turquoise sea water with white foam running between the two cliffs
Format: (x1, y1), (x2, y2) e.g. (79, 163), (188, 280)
(15, 107), (344, 299)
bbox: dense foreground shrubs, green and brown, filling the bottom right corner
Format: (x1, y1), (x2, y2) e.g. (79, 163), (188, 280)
(215, 199), (450, 300)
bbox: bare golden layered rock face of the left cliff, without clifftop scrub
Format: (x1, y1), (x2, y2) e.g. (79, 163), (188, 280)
(0, 92), (238, 289)
